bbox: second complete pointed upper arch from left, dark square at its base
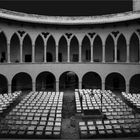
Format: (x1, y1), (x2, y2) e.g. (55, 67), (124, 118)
(22, 34), (32, 62)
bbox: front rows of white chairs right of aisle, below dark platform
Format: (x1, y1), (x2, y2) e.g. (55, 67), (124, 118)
(79, 120), (140, 138)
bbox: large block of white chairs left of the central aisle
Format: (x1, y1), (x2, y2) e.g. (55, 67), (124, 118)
(0, 91), (63, 138)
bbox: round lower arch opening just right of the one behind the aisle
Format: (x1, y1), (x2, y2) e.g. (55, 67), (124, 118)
(82, 72), (102, 89)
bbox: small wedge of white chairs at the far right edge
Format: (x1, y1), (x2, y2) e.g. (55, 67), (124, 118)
(122, 92), (140, 111)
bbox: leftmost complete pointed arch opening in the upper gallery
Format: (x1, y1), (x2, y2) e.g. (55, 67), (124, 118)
(10, 33), (20, 63)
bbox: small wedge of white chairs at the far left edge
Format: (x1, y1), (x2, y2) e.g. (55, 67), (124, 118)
(0, 91), (21, 114)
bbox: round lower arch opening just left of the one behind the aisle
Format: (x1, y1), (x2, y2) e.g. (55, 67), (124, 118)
(36, 72), (56, 91)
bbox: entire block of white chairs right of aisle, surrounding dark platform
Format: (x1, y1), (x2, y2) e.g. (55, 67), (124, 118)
(75, 89), (140, 138)
